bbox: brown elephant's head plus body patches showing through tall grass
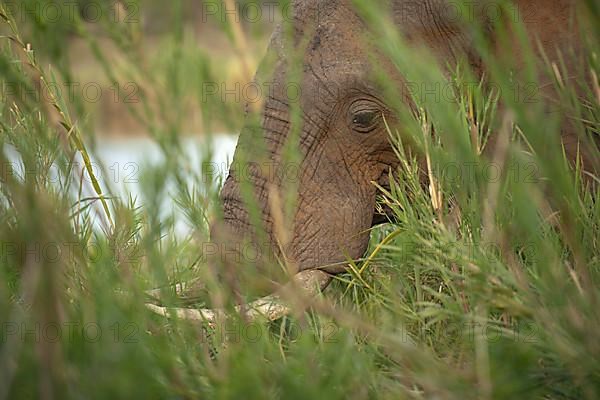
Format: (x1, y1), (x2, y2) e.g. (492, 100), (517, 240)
(149, 0), (592, 318)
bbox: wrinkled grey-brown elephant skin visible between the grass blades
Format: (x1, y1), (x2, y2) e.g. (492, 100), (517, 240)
(212, 0), (592, 290)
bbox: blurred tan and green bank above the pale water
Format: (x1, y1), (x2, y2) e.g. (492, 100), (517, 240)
(3, 0), (278, 137)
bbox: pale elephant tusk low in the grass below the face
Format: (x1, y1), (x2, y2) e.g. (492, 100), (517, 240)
(146, 269), (332, 323)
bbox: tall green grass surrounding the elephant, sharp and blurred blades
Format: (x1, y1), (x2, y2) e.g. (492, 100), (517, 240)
(0, 1), (600, 400)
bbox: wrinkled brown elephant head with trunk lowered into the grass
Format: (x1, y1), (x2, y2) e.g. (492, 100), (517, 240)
(213, 1), (397, 294)
